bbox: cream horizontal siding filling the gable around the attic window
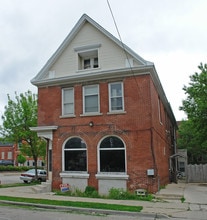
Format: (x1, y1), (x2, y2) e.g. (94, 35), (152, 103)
(50, 22), (140, 77)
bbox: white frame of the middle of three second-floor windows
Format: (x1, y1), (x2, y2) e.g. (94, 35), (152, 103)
(83, 84), (100, 114)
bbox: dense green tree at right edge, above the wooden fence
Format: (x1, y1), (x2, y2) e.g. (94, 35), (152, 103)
(178, 63), (207, 163)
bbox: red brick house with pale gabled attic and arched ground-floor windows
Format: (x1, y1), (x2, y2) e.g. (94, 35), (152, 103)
(31, 14), (177, 194)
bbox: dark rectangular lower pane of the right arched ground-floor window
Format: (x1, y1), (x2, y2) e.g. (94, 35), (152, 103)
(100, 150), (125, 172)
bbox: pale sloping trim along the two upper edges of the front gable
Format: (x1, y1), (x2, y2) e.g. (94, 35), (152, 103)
(31, 14), (153, 85)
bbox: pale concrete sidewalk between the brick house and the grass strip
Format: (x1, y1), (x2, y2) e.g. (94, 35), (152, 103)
(0, 184), (189, 218)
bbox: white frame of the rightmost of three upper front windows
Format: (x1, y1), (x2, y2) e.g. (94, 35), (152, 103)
(108, 82), (124, 112)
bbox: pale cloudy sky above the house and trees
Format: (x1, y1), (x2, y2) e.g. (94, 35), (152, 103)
(0, 0), (207, 120)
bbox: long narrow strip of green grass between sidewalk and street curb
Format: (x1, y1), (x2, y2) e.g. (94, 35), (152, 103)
(0, 196), (143, 212)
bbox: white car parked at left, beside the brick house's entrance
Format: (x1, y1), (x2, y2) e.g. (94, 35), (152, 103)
(20, 169), (47, 183)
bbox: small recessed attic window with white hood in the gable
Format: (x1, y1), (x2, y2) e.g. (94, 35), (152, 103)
(74, 44), (101, 70)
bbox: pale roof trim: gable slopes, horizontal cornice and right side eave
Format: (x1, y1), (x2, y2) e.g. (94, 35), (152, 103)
(31, 14), (176, 124)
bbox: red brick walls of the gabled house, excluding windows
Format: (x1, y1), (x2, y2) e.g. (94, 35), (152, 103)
(38, 75), (174, 192)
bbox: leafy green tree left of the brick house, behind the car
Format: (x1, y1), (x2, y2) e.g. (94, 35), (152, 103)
(0, 91), (46, 177)
